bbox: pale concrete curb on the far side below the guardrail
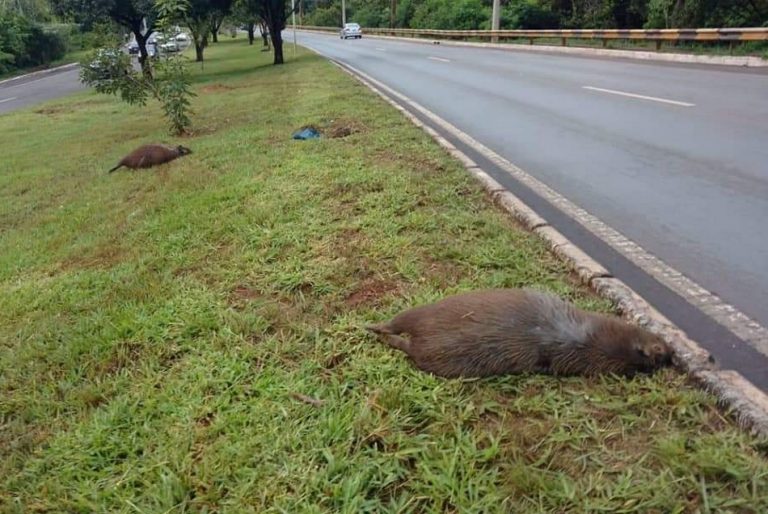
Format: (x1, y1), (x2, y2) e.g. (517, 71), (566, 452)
(297, 29), (768, 68)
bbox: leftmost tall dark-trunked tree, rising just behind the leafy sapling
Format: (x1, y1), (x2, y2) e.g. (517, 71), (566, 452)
(51, 0), (157, 75)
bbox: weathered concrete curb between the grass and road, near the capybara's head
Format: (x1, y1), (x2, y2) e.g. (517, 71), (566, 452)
(317, 52), (768, 437)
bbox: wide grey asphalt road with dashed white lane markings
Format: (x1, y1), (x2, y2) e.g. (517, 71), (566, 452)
(299, 33), (768, 332)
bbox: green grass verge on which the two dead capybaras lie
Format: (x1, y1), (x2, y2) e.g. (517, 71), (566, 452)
(0, 40), (768, 513)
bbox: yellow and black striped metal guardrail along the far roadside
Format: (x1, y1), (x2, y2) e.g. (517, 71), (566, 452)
(300, 25), (768, 50)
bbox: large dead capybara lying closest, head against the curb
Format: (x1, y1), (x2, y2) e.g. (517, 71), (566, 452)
(367, 289), (672, 378)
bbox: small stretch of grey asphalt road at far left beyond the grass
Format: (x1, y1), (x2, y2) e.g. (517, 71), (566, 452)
(0, 67), (84, 114)
